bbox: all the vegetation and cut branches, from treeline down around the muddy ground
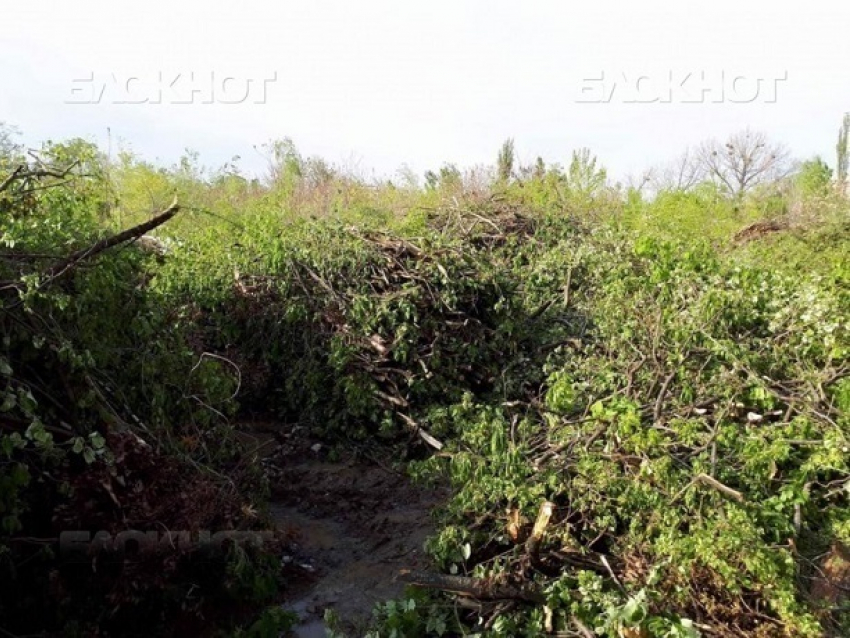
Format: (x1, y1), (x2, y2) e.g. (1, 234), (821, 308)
(0, 121), (850, 637)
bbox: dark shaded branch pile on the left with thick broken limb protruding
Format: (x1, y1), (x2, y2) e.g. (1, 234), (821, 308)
(0, 155), (274, 635)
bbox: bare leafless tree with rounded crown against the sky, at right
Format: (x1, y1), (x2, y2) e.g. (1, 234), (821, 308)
(696, 129), (792, 197)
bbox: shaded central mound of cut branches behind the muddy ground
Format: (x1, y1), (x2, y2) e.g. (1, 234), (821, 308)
(219, 212), (544, 449)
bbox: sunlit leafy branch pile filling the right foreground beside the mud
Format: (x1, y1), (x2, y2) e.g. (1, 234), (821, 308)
(406, 231), (850, 638)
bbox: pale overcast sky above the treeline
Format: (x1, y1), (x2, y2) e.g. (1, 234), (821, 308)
(0, 0), (850, 179)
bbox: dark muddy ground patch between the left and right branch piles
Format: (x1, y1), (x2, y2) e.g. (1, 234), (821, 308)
(240, 425), (447, 638)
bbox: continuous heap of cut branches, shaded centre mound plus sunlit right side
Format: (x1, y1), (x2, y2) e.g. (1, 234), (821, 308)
(161, 202), (850, 637)
